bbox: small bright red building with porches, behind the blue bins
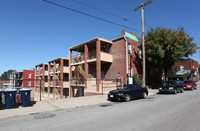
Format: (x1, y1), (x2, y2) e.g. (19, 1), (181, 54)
(10, 69), (35, 88)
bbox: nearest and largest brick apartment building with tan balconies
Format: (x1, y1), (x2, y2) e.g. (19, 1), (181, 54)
(69, 31), (142, 97)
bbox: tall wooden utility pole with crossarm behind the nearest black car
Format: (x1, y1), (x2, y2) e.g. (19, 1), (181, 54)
(134, 0), (153, 87)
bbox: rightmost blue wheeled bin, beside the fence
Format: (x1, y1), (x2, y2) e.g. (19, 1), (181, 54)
(19, 88), (31, 107)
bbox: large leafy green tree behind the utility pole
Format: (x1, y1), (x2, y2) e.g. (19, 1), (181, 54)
(145, 27), (196, 78)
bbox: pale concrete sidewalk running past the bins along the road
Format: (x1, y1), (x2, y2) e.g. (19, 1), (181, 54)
(0, 89), (158, 119)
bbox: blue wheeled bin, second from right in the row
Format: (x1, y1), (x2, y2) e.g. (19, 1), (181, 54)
(3, 89), (17, 109)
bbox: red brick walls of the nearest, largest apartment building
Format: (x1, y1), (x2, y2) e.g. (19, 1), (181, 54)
(105, 31), (142, 83)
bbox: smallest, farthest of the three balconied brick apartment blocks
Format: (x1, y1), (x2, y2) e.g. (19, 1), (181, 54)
(35, 63), (48, 94)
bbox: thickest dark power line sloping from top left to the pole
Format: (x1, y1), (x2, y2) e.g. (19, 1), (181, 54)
(43, 0), (141, 33)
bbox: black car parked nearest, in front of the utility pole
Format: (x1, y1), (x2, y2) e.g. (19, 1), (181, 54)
(108, 85), (148, 102)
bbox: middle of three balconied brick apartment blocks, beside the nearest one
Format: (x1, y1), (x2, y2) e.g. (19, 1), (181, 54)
(48, 57), (69, 98)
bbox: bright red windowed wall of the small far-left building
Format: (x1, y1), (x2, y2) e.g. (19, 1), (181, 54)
(23, 69), (35, 88)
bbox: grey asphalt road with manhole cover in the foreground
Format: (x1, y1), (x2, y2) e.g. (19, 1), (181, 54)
(0, 87), (200, 131)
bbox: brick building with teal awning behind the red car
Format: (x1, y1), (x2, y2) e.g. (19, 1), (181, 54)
(175, 58), (199, 81)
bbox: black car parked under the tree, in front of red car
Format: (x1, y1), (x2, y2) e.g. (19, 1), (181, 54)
(159, 80), (184, 94)
